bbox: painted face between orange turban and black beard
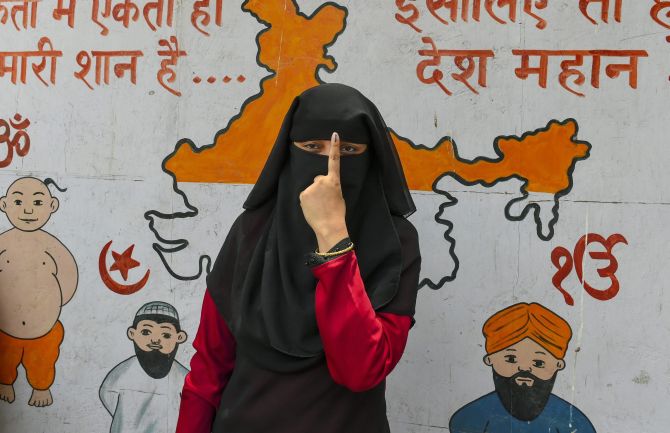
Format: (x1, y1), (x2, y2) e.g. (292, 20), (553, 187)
(484, 338), (565, 386)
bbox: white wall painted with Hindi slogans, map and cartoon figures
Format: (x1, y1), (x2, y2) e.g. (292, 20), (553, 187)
(0, 0), (670, 433)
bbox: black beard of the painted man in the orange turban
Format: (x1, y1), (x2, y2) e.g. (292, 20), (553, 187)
(493, 370), (558, 421)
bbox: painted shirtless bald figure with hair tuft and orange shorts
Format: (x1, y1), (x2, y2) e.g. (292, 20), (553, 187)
(0, 177), (78, 406)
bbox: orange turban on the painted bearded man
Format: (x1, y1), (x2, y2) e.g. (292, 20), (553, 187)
(482, 303), (572, 359)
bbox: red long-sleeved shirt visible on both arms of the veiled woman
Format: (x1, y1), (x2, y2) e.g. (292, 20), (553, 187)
(177, 251), (411, 433)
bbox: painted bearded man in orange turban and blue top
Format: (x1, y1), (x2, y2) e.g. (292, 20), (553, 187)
(449, 303), (595, 433)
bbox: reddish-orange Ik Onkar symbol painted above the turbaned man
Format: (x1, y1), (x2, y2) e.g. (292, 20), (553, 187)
(551, 233), (628, 305)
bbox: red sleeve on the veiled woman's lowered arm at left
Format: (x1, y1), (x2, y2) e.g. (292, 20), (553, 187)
(176, 291), (235, 433)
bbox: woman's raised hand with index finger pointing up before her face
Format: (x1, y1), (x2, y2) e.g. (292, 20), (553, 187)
(300, 132), (349, 252)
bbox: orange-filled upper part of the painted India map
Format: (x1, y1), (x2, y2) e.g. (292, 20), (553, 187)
(164, 0), (589, 194)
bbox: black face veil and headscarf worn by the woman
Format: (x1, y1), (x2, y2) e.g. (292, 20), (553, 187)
(207, 84), (420, 372)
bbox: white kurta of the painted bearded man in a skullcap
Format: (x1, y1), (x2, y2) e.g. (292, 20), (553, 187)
(100, 356), (188, 433)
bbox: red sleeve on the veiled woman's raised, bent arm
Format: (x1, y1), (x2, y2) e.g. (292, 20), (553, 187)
(312, 251), (411, 392)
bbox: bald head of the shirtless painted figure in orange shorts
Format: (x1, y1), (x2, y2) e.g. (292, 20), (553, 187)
(0, 177), (59, 232)
